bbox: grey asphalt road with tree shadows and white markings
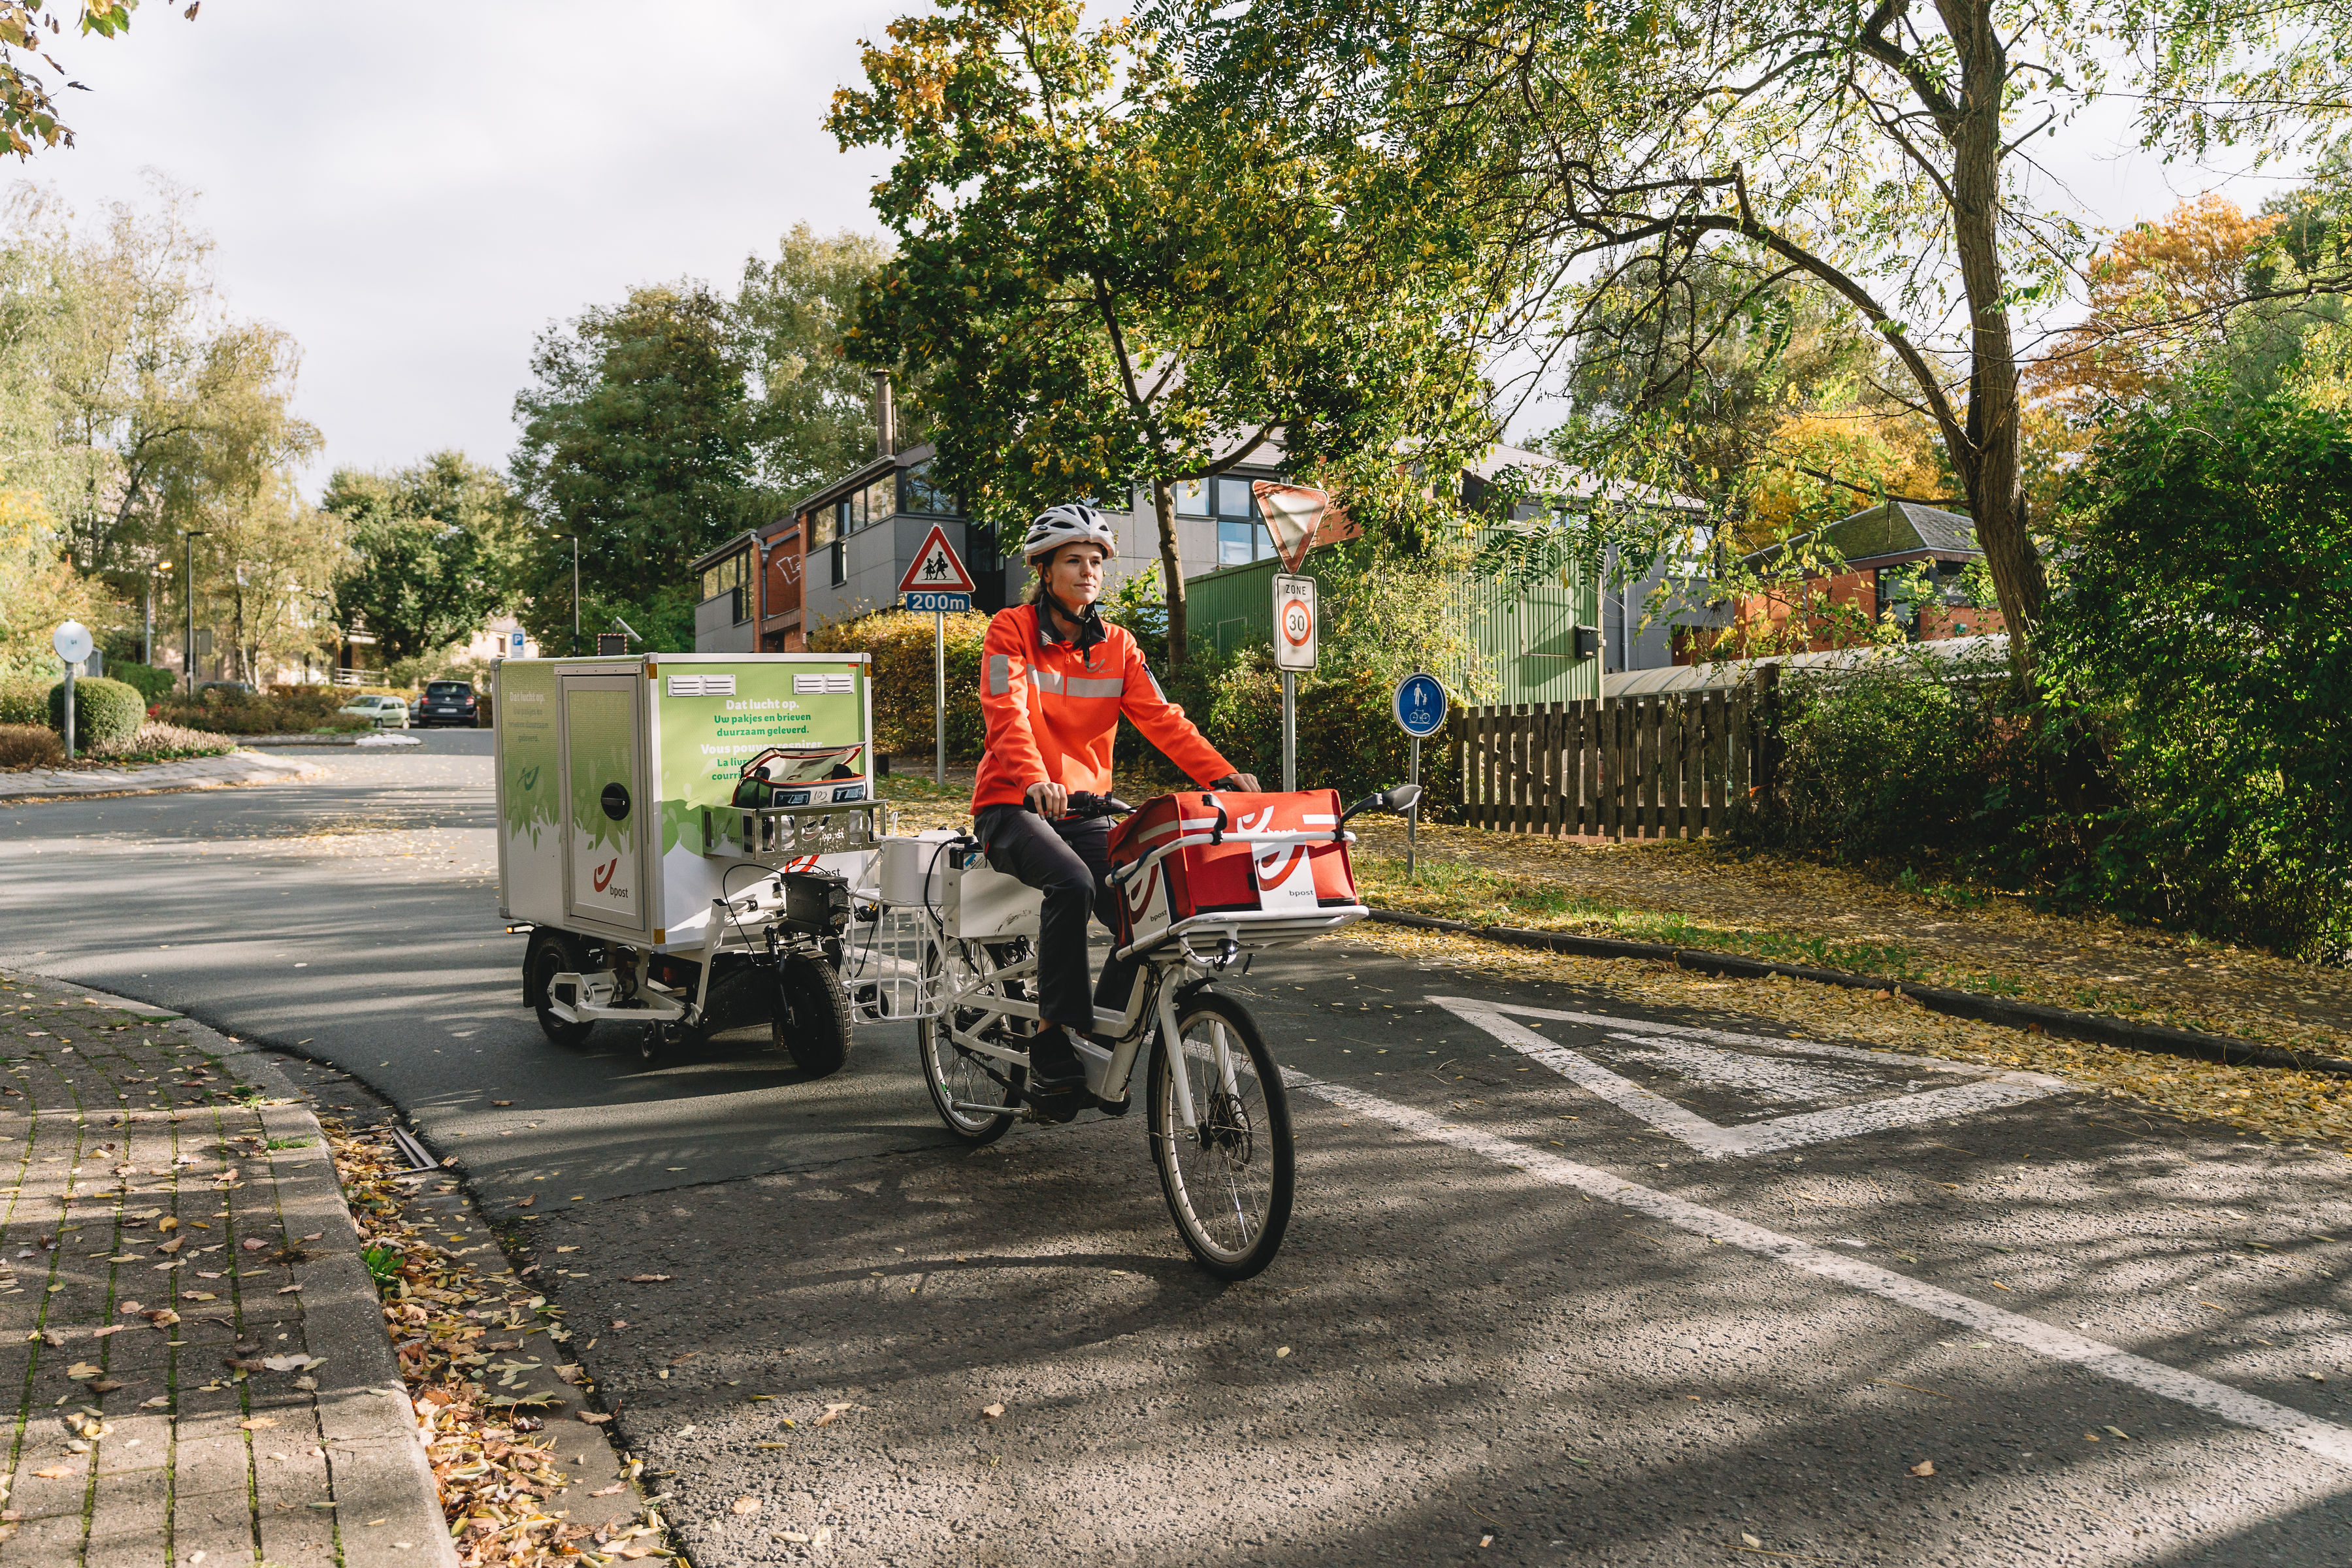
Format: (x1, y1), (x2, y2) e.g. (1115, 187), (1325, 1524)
(0, 734), (2352, 1568)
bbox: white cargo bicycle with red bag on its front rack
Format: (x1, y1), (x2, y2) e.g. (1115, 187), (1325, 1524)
(844, 785), (1418, 1279)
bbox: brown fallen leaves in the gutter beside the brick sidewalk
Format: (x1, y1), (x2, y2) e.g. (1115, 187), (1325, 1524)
(322, 1119), (673, 1568)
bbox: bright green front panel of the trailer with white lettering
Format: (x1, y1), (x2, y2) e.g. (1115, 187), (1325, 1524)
(659, 661), (873, 853)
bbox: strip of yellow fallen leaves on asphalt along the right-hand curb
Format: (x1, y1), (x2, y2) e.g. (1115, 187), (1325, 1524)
(1322, 921), (2352, 1154)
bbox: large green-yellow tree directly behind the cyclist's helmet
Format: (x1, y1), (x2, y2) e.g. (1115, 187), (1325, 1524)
(828, 0), (1491, 663)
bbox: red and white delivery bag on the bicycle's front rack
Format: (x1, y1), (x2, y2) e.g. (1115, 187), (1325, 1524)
(1110, 790), (1357, 945)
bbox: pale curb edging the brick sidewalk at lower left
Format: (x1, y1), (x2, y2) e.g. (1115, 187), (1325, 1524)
(21, 971), (459, 1568)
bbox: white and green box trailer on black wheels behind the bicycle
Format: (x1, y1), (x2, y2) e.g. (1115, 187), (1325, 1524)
(491, 653), (882, 1072)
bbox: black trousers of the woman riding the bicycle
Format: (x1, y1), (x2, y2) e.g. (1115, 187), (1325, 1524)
(972, 806), (1136, 1034)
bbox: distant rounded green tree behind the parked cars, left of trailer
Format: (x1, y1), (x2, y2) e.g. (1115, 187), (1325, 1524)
(320, 451), (522, 663)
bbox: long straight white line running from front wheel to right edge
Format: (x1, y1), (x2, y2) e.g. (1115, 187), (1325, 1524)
(1282, 1070), (2352, 1469)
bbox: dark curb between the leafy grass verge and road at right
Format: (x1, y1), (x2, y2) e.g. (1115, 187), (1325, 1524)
(1371, 910), (2352, 1079)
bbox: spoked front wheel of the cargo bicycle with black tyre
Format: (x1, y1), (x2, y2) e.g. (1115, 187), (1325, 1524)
(1145, 992), (1296, 1279)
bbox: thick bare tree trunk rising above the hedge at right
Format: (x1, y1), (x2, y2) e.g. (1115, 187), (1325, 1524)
(1943, 0), (2049, 681)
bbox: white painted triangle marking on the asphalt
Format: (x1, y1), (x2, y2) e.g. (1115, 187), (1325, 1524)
(1430, 997), (2065, 1159)
